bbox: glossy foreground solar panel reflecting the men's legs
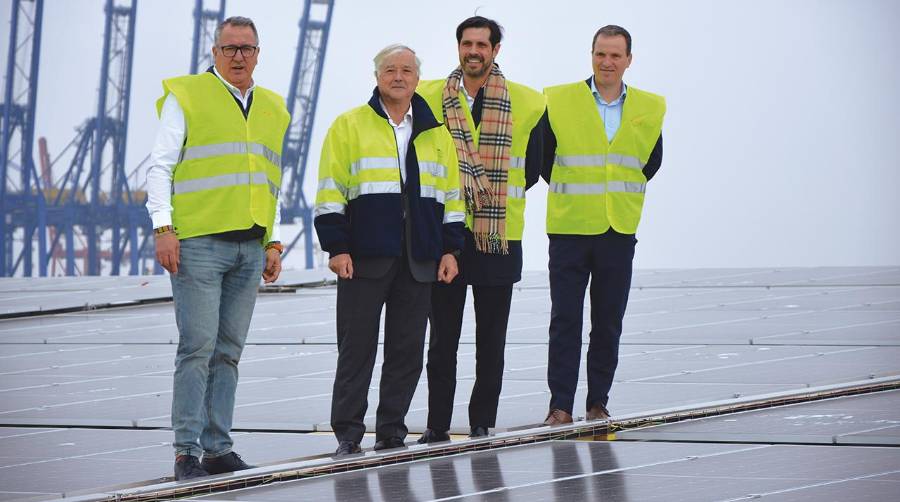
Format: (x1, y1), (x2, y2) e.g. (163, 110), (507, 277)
(188, 441), (900, 502)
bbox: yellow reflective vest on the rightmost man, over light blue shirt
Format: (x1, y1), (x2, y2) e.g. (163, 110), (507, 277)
(544, 81), (666, 235)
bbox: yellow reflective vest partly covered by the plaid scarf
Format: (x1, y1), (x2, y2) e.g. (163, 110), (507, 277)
(416, 80), (544, 241)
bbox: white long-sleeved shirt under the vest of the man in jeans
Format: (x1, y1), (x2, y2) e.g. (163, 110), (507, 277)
(147, 67), (281, 241)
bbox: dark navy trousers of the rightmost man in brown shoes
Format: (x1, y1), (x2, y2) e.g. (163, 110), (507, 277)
(547, 232), (637, 413)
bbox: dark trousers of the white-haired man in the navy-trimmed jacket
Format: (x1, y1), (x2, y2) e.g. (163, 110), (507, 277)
(331, 258), (431, 442)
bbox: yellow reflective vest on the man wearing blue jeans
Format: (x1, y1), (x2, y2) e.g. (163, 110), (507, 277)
(156, 72), (290, 243)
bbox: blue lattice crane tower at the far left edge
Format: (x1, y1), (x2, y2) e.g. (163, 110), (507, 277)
(0, 0), (46, 277)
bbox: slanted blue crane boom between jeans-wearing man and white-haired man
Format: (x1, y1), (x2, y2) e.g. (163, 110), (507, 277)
(281, 0), (334, 268)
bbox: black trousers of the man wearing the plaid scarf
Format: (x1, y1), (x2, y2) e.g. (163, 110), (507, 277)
(427, 280), (512, 431)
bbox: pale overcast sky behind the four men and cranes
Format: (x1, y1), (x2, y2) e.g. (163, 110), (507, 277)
(0, 0), (900, 270)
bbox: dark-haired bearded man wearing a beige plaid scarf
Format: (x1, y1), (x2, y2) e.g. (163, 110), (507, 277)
(418, 16), (545, 443)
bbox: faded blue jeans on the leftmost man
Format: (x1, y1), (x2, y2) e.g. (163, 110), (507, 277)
(171, 237), (265, 458)
